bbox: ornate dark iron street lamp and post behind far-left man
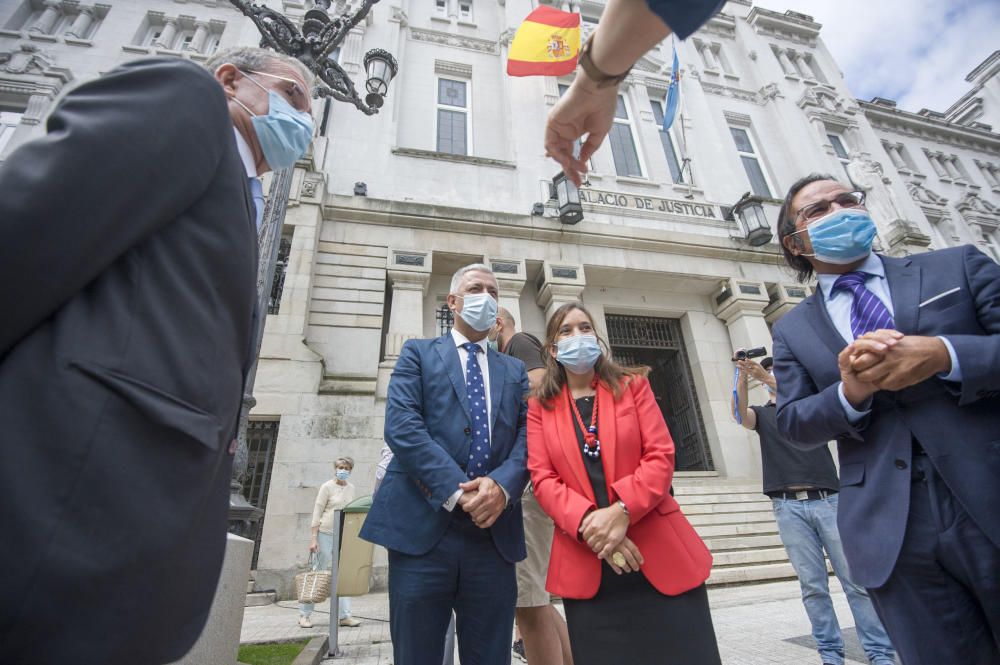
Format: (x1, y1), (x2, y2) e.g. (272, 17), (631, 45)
(229, 0), (399, 536)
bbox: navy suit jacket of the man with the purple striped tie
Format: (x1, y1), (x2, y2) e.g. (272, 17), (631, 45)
(774, 245), (1000, 588)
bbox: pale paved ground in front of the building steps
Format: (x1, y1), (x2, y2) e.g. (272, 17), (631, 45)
(242, 578), (900, 665)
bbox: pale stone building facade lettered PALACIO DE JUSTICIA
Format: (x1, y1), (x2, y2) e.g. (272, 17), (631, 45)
(0, 0), (1000, 593)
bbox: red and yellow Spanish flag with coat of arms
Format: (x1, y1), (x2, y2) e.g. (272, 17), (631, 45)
(507, 5), (580, 76)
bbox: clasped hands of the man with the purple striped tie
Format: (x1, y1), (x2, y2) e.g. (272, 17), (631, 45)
(837, 329), (951, 406)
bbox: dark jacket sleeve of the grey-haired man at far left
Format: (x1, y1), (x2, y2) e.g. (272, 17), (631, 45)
(0, 58), (233, 356)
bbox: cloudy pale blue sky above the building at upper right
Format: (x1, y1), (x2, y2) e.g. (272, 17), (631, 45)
(754, 0), (1000, 111)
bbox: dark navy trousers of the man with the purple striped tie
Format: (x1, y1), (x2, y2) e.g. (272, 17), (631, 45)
(868, 455), (1000, 665)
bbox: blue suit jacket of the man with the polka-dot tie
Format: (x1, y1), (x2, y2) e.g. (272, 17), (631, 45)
(361, 334), (528, 563)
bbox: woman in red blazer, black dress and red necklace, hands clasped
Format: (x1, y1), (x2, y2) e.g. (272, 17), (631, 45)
(528, 303), (721, 665)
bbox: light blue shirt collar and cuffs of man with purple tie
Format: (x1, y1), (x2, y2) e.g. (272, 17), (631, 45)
(816, 252), (962, 423)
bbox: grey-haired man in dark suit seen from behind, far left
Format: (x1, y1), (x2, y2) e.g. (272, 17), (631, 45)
(0, 49), (310, 665)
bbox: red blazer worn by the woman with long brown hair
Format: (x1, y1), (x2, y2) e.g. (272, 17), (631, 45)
(528, 377), (712, 598)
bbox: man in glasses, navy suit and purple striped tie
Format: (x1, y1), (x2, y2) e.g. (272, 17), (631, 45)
(774, 175), (1000, 665)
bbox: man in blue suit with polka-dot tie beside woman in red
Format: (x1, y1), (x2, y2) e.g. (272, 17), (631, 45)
(361, 264), (528, 665)
